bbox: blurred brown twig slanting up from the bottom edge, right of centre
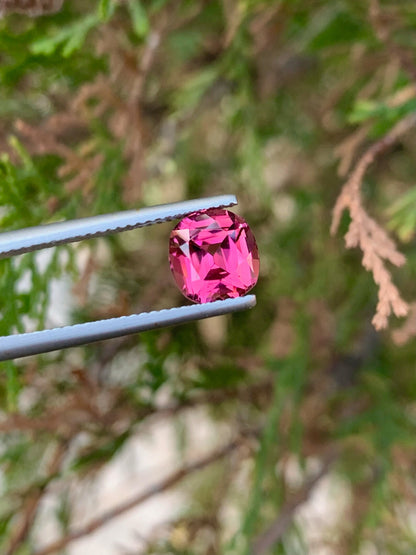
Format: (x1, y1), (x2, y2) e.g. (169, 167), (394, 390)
(250, 449), (339, 555)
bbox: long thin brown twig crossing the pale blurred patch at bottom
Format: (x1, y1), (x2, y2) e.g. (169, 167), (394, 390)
(34, 432), (258, 555)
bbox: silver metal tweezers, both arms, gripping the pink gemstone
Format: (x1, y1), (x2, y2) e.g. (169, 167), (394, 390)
(0, 195), (256, 361)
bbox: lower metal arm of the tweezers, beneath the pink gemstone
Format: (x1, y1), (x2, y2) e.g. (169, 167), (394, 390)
(0, 295), (256, 361)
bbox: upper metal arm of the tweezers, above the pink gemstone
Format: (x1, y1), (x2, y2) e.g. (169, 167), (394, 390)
(0, 195), (237, 258)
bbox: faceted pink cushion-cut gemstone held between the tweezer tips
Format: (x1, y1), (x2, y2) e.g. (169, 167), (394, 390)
(169, 209), (259, 303)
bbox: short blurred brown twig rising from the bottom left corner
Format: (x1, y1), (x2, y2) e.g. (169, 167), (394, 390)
(5, 442), (67, 555)
